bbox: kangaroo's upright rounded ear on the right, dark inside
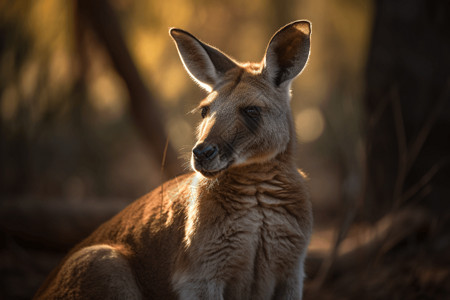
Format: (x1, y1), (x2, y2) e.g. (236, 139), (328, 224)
(263, 21), (311, 86)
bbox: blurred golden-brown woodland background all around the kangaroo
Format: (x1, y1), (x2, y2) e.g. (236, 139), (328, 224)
(0, 0), (450, 299)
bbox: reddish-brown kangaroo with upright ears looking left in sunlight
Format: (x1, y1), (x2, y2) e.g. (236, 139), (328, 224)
(35, 21), (312, 300)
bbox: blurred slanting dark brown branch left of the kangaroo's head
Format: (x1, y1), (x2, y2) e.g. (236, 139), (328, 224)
(76, 0), (182, 178)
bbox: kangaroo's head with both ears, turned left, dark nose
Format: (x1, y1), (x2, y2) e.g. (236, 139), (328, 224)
(170, 21), (311, 177)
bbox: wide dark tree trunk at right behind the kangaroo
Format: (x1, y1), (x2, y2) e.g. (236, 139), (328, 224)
(364, 0), (450, 220)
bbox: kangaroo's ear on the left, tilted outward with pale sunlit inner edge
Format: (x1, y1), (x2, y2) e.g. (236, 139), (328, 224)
(169, 28), (237, 92)
